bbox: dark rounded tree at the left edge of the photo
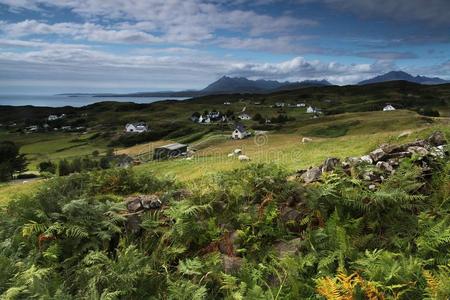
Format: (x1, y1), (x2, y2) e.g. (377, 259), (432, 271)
(0, 141), (27, 181)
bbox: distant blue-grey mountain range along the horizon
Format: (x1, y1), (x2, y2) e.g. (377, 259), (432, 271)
(84, 71), (449, 98)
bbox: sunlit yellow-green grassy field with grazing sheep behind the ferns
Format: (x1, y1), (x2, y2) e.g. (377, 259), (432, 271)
(133, 111), (450, 180)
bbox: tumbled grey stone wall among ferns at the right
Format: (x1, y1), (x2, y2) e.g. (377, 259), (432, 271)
(296, 131), (449, 185)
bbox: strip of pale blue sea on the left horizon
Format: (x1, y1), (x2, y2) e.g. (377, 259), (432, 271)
(0, 95), (188, 107)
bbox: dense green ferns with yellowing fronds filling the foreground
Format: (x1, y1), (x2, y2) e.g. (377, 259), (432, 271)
(0, 132), (450, 299)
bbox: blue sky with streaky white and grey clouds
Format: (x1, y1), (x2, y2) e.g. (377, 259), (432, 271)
(0, 0), (450, 94)
